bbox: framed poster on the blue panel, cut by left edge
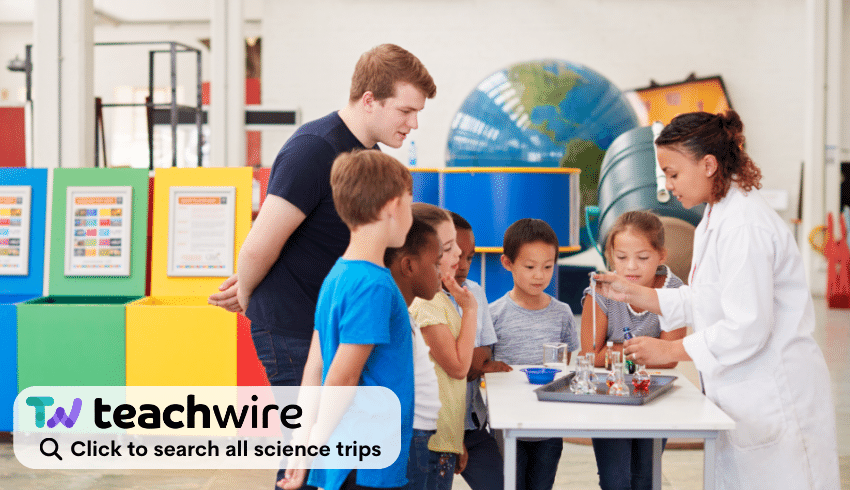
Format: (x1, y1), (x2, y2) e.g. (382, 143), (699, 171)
(0, 185), (32, 276)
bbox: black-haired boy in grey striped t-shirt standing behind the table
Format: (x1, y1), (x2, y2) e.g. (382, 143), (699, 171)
(490, 218), (579, 490)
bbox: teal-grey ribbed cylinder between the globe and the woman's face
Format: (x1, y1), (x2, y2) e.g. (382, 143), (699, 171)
(596, 127), (704, 247)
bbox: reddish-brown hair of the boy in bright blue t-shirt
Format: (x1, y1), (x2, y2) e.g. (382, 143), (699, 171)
(331, 150), (413, 229)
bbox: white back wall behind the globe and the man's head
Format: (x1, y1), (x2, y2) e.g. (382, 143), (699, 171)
(263, 0), (828, 222)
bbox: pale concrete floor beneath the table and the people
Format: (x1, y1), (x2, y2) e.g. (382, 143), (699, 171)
(0, 298), (850, 490)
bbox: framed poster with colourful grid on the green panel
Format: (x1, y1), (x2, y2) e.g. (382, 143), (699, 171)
(65, 186), (133, 276)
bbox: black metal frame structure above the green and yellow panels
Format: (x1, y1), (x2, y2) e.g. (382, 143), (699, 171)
(95, 41), (203, 170)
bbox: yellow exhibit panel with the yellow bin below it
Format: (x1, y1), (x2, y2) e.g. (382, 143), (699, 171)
(127, 167), (252, 386)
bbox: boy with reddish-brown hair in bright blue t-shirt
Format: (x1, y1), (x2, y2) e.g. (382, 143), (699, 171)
(278, 150), (414, 490)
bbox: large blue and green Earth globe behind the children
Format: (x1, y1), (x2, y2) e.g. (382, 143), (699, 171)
(446, 59), (638, 204)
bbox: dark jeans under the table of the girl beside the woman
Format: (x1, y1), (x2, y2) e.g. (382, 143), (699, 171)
(593, 439), (667, 490)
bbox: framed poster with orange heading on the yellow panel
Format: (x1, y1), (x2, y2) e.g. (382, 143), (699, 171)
(168, 186), (236, 277)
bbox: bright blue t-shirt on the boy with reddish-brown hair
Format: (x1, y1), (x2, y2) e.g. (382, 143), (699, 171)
(309, 258), (414, 490)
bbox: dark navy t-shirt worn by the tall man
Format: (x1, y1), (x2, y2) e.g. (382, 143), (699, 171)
(246, 112), (376, 339)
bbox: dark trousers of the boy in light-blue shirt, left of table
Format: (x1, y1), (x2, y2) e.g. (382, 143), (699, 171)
(460, 429), (505, 490)
